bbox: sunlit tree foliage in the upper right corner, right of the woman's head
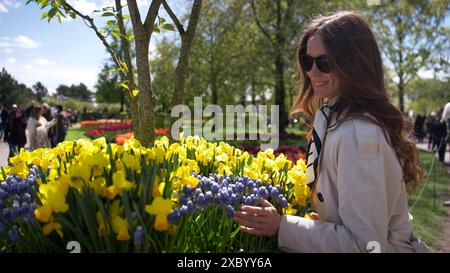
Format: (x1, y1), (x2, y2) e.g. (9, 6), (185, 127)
(367, 0), (449, 112)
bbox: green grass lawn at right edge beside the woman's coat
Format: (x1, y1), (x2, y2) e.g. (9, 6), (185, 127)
(409, 151), (450, 250)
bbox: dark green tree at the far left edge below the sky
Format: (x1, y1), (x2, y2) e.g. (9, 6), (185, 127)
(0, 68), (36, 107)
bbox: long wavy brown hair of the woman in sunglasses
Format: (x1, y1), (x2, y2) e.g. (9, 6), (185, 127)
(291, 11), (424, 192)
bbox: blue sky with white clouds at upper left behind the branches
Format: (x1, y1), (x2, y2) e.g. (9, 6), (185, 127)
(0, 0), (181, 93)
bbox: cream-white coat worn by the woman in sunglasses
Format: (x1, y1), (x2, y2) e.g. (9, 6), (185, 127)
(278, 114), (428, 252)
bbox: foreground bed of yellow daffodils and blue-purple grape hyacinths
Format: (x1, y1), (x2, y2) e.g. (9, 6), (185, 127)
(0, 137), (309, 252)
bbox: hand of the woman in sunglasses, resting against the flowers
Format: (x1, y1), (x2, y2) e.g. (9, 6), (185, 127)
(233, 199), (281, 236)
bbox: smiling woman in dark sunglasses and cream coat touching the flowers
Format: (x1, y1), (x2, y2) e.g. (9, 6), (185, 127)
(234, 12), (428, 252)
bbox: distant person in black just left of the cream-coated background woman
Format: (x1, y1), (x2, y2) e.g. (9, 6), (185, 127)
(9, 105), (27, 157)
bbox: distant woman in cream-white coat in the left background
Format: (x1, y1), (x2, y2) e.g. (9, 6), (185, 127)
(26, 106), (56, 151)
